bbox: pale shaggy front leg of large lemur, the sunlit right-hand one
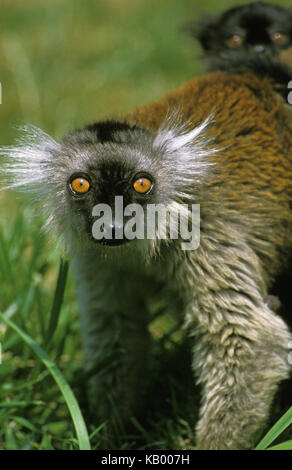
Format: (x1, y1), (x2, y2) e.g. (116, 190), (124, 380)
(187, 233), (290, 449)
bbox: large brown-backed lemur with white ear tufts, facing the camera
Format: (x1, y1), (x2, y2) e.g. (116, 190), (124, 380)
(1, 50), (292, 449)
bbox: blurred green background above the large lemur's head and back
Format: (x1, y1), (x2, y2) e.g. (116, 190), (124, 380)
(0, 0), (291, 140)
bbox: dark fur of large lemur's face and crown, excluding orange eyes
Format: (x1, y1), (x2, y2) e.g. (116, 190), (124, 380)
(64, 121), (159, 245)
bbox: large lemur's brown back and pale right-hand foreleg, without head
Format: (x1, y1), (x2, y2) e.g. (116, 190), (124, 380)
(128, 72), (292, 449)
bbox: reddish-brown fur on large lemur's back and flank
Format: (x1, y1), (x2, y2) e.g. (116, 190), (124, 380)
(126, 72), (292, 281)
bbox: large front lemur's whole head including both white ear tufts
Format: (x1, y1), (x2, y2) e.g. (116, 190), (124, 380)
(1, 118), (213, 258)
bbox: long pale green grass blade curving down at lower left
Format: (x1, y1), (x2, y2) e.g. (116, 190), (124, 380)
(0, 313), (91, 450)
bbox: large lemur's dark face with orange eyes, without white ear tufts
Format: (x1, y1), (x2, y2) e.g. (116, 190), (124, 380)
(64, 123), (160, 246)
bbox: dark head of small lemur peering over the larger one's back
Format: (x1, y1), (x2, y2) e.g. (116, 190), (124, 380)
(186, 2), (292, 66)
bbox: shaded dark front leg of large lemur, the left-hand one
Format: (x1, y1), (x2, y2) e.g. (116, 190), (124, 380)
(74, 253), (149, 434)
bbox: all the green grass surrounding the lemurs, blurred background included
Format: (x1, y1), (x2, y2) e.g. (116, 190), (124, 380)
(0, 0), (292, 449)
